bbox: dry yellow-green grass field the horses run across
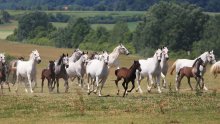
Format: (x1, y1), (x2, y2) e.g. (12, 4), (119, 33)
(0, 40), (220, 124)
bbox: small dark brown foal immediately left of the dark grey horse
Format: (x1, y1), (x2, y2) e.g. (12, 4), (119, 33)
(41, 61), (55, 92)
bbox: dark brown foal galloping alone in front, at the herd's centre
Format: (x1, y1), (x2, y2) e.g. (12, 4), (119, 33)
(115, 61), (141, 97)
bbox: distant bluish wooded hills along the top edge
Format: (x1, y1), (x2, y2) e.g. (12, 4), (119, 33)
(0, 0), (220, 12)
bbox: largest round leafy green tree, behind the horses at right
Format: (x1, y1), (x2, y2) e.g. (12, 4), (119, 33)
(133, 2), (208, 54)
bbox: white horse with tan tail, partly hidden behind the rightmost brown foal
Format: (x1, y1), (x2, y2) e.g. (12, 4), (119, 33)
(170, 50), (216, 91)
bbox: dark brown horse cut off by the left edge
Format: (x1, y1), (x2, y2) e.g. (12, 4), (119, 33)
(0, 62), (11, 94)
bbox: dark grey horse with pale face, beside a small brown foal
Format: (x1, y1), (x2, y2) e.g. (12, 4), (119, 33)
(54, 54), (69, 93)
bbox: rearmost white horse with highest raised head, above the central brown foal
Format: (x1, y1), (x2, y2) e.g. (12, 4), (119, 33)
(108, 44), (129, 69)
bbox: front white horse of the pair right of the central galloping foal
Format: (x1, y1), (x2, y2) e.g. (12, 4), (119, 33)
(136, 49), (162, 93)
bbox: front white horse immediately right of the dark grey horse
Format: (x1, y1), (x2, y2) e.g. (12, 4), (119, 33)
(66, 53), (88, 87)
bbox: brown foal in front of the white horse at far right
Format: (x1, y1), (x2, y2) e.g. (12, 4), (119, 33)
(177, 58), (204, 90)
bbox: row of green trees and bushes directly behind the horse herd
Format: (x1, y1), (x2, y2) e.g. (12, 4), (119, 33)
(8, 2), (220, 58)
